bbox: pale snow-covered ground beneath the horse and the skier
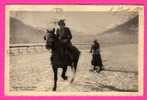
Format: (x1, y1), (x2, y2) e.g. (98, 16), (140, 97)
(10, 44), (138, 92)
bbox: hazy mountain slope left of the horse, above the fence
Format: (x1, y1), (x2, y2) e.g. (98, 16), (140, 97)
(10, 17), (45, 44)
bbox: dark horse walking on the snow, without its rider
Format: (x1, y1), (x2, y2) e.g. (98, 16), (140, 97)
(44, 30), (80, 91)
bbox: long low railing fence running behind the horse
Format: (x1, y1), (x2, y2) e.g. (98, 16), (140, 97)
(9, 43), (90, 55)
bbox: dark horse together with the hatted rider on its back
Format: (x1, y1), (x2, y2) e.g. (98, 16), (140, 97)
(44, 20), (80, 91)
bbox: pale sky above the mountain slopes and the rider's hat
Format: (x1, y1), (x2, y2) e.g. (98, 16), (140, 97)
(10, 11), (135, 34)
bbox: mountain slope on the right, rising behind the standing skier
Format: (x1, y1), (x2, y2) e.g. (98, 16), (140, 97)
(97, 15), (138, 45)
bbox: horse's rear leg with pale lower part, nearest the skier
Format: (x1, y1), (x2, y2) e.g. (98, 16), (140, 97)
(71, 48), (81, 83)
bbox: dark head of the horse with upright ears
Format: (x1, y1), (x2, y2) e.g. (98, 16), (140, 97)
(44, 29), (56, 49)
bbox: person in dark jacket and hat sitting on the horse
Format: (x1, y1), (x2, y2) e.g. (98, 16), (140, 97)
(56, 19), (72, 59)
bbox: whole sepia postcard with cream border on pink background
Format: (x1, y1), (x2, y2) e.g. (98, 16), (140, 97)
(5, 5), (144, 96)
